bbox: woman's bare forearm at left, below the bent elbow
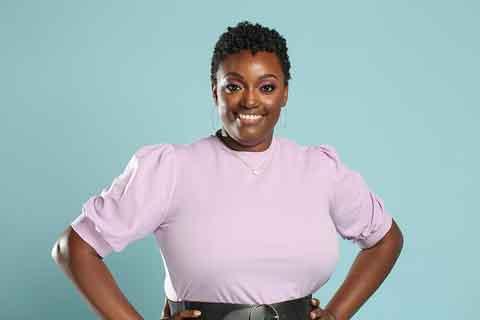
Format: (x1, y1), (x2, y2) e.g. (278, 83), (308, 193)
(53, 239), (143, 320)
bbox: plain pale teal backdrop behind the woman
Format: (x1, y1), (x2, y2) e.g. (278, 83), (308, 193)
(0, 0), (480, 320)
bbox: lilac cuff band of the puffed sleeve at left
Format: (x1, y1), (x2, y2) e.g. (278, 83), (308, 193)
(70, 214), (113, 258)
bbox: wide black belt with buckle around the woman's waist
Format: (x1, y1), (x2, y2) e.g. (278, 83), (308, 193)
(167, 294), (313, 320)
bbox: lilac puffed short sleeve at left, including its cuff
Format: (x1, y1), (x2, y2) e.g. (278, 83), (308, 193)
(71, 144), (175, 257)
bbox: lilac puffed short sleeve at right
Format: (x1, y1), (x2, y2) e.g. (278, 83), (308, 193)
(318, 145), (393, 249)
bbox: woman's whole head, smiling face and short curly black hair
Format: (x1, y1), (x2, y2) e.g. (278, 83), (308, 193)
(211, 22), (290, 151)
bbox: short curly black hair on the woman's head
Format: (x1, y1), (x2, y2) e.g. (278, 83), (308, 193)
(210, 21), (291, 85)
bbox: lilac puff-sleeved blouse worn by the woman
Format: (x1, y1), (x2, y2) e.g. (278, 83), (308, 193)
(71, 135), (392, 304)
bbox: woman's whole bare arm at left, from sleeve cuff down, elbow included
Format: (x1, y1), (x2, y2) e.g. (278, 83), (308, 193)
(52, 226), (143, 320)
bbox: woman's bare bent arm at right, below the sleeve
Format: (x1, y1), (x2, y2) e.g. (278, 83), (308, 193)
(325, 221), (403, 320)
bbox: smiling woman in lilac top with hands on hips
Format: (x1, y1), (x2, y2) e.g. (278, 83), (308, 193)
(52, 22), (403, 320)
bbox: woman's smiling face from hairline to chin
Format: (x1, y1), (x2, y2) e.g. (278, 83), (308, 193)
(212, 50), (288, 151)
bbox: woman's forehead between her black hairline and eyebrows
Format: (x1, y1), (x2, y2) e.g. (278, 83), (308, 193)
(217, 50), (283, 78)
